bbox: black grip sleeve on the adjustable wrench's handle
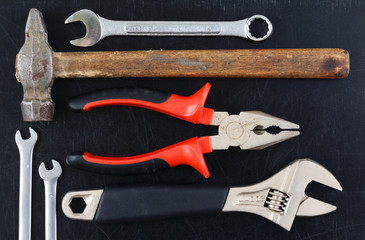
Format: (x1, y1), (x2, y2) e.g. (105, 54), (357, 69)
(94, 185), (229, 223)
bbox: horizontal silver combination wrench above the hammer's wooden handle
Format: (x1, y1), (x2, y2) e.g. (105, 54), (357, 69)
(65, 9), (273, 47)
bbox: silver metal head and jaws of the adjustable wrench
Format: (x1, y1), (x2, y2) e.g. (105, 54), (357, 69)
(222, 159), (342, 231)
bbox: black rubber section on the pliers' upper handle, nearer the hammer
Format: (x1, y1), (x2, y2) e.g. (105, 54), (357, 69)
(68, 88), (171, 110)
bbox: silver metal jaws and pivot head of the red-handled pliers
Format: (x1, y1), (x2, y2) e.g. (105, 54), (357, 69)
(210, 111), (299, 150)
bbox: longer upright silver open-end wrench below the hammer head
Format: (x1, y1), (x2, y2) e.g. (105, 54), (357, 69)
(15, 128), (38, 240)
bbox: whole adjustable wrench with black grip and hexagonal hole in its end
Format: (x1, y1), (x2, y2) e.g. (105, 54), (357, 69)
(62, 159), (342, 231)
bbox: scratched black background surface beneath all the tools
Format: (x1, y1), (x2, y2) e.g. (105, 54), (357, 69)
(0, 0), (365, 240)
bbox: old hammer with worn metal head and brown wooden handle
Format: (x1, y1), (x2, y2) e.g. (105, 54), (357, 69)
(15, 8), (350, 121)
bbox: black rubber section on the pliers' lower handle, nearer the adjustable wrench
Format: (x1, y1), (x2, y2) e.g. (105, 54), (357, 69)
(66, 152), (170, 175)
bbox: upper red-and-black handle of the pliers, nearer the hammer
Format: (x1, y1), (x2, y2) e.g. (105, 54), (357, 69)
(69, 83), (214, 125)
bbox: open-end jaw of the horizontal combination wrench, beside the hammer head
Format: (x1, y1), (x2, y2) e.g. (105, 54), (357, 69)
(65, 9), (102, 47)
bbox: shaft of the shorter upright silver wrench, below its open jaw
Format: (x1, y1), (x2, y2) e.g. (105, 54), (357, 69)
(44, 178), (58, 240)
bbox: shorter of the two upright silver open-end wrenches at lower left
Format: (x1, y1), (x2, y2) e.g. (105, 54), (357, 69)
(38, 160), (62, 240)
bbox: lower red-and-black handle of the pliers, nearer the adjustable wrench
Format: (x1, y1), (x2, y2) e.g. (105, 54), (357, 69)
(66, 137), (212, 178)
